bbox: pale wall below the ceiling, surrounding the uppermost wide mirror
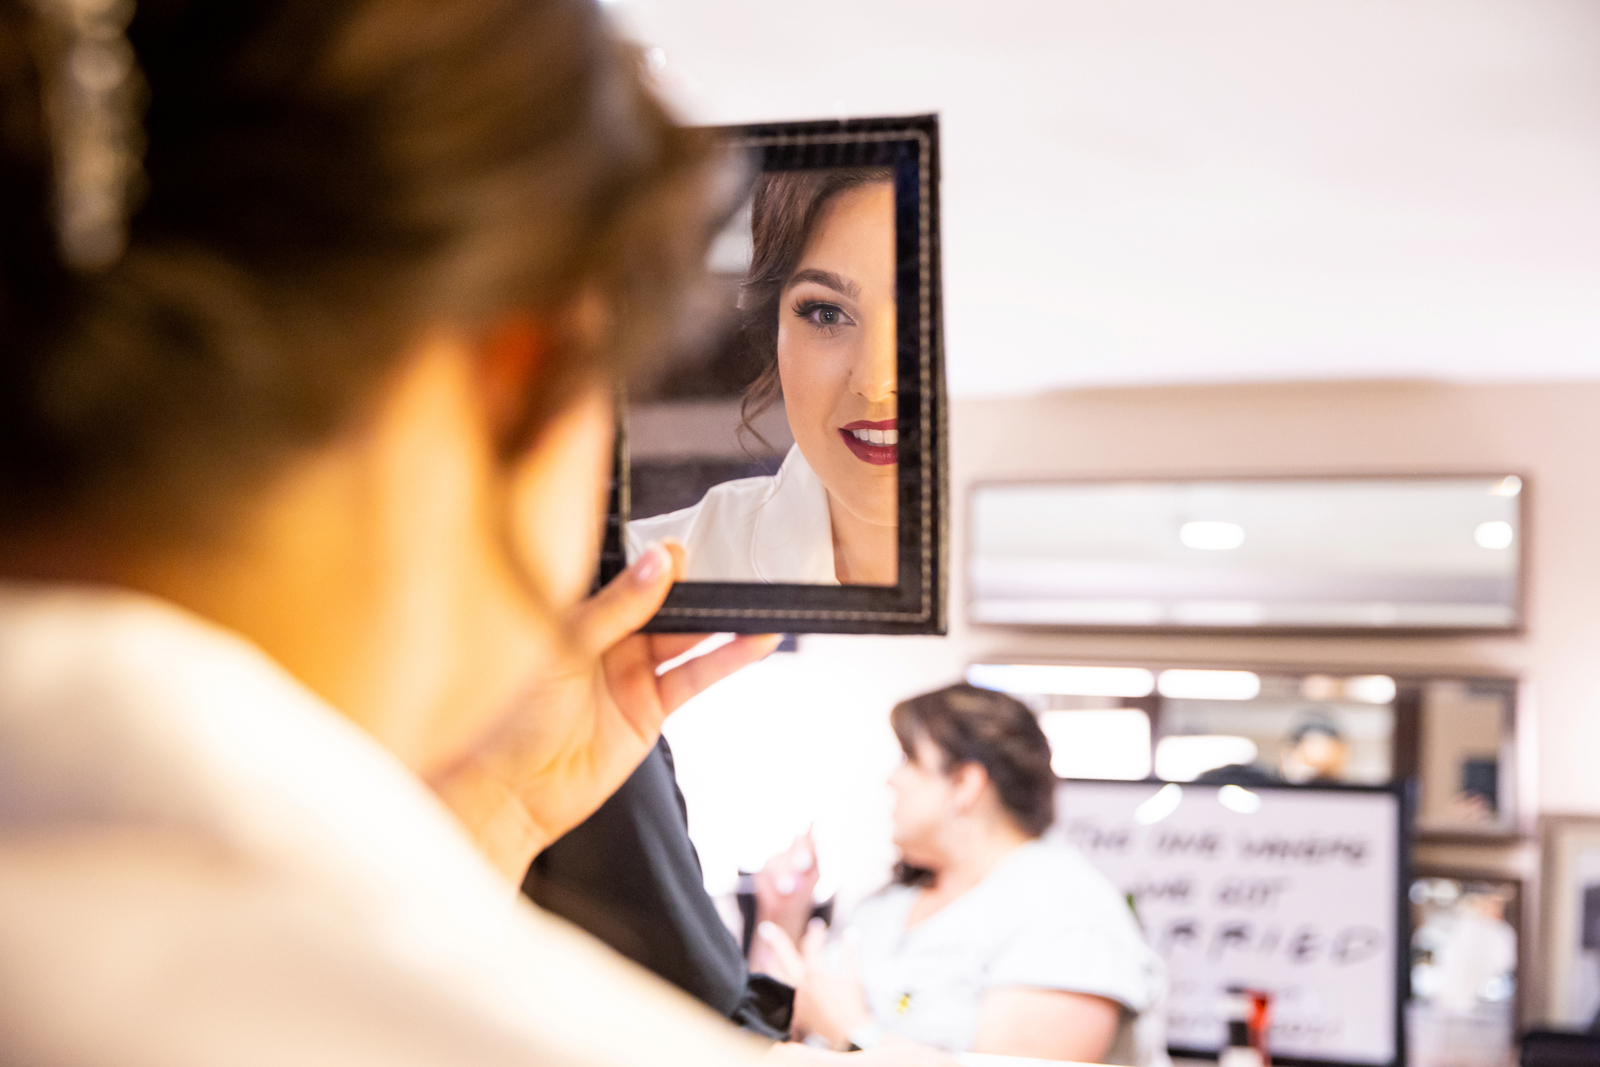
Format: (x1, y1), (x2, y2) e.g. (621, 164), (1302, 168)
(667, 382), (1600, 896)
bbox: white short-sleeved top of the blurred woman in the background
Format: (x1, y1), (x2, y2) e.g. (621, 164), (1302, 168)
(846, 841), (1166, 1067)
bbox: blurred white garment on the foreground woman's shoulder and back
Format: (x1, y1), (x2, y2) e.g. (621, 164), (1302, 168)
(0, 584), (763, 1067)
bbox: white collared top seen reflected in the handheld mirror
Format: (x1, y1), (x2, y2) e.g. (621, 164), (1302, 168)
(626, 445), (838, 585)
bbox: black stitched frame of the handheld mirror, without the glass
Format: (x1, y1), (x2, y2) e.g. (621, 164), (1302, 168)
(600, 115), (949, 633)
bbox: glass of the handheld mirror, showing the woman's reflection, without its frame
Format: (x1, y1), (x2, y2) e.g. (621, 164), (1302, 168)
(624, 168), (899, 585)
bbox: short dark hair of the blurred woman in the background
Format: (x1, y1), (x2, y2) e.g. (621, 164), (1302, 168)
(890, 685), (1056, 837)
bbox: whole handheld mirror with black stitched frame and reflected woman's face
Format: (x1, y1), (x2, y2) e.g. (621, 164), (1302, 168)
(602, 117), (947, 633)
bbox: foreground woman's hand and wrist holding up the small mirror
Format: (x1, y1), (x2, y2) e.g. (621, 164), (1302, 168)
(434, 544), (778, 883)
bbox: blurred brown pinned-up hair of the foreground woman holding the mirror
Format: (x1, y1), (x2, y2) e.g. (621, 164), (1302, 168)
(0, 0), (712, 533)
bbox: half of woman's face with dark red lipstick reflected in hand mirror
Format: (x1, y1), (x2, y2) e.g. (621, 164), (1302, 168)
(778, 182), (899, 528)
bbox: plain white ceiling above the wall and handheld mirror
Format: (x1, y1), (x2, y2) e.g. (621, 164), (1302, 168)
(610, 0), (1600, 395)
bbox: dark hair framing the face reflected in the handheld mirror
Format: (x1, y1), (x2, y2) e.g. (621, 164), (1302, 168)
(739, 166), (894, 438)
